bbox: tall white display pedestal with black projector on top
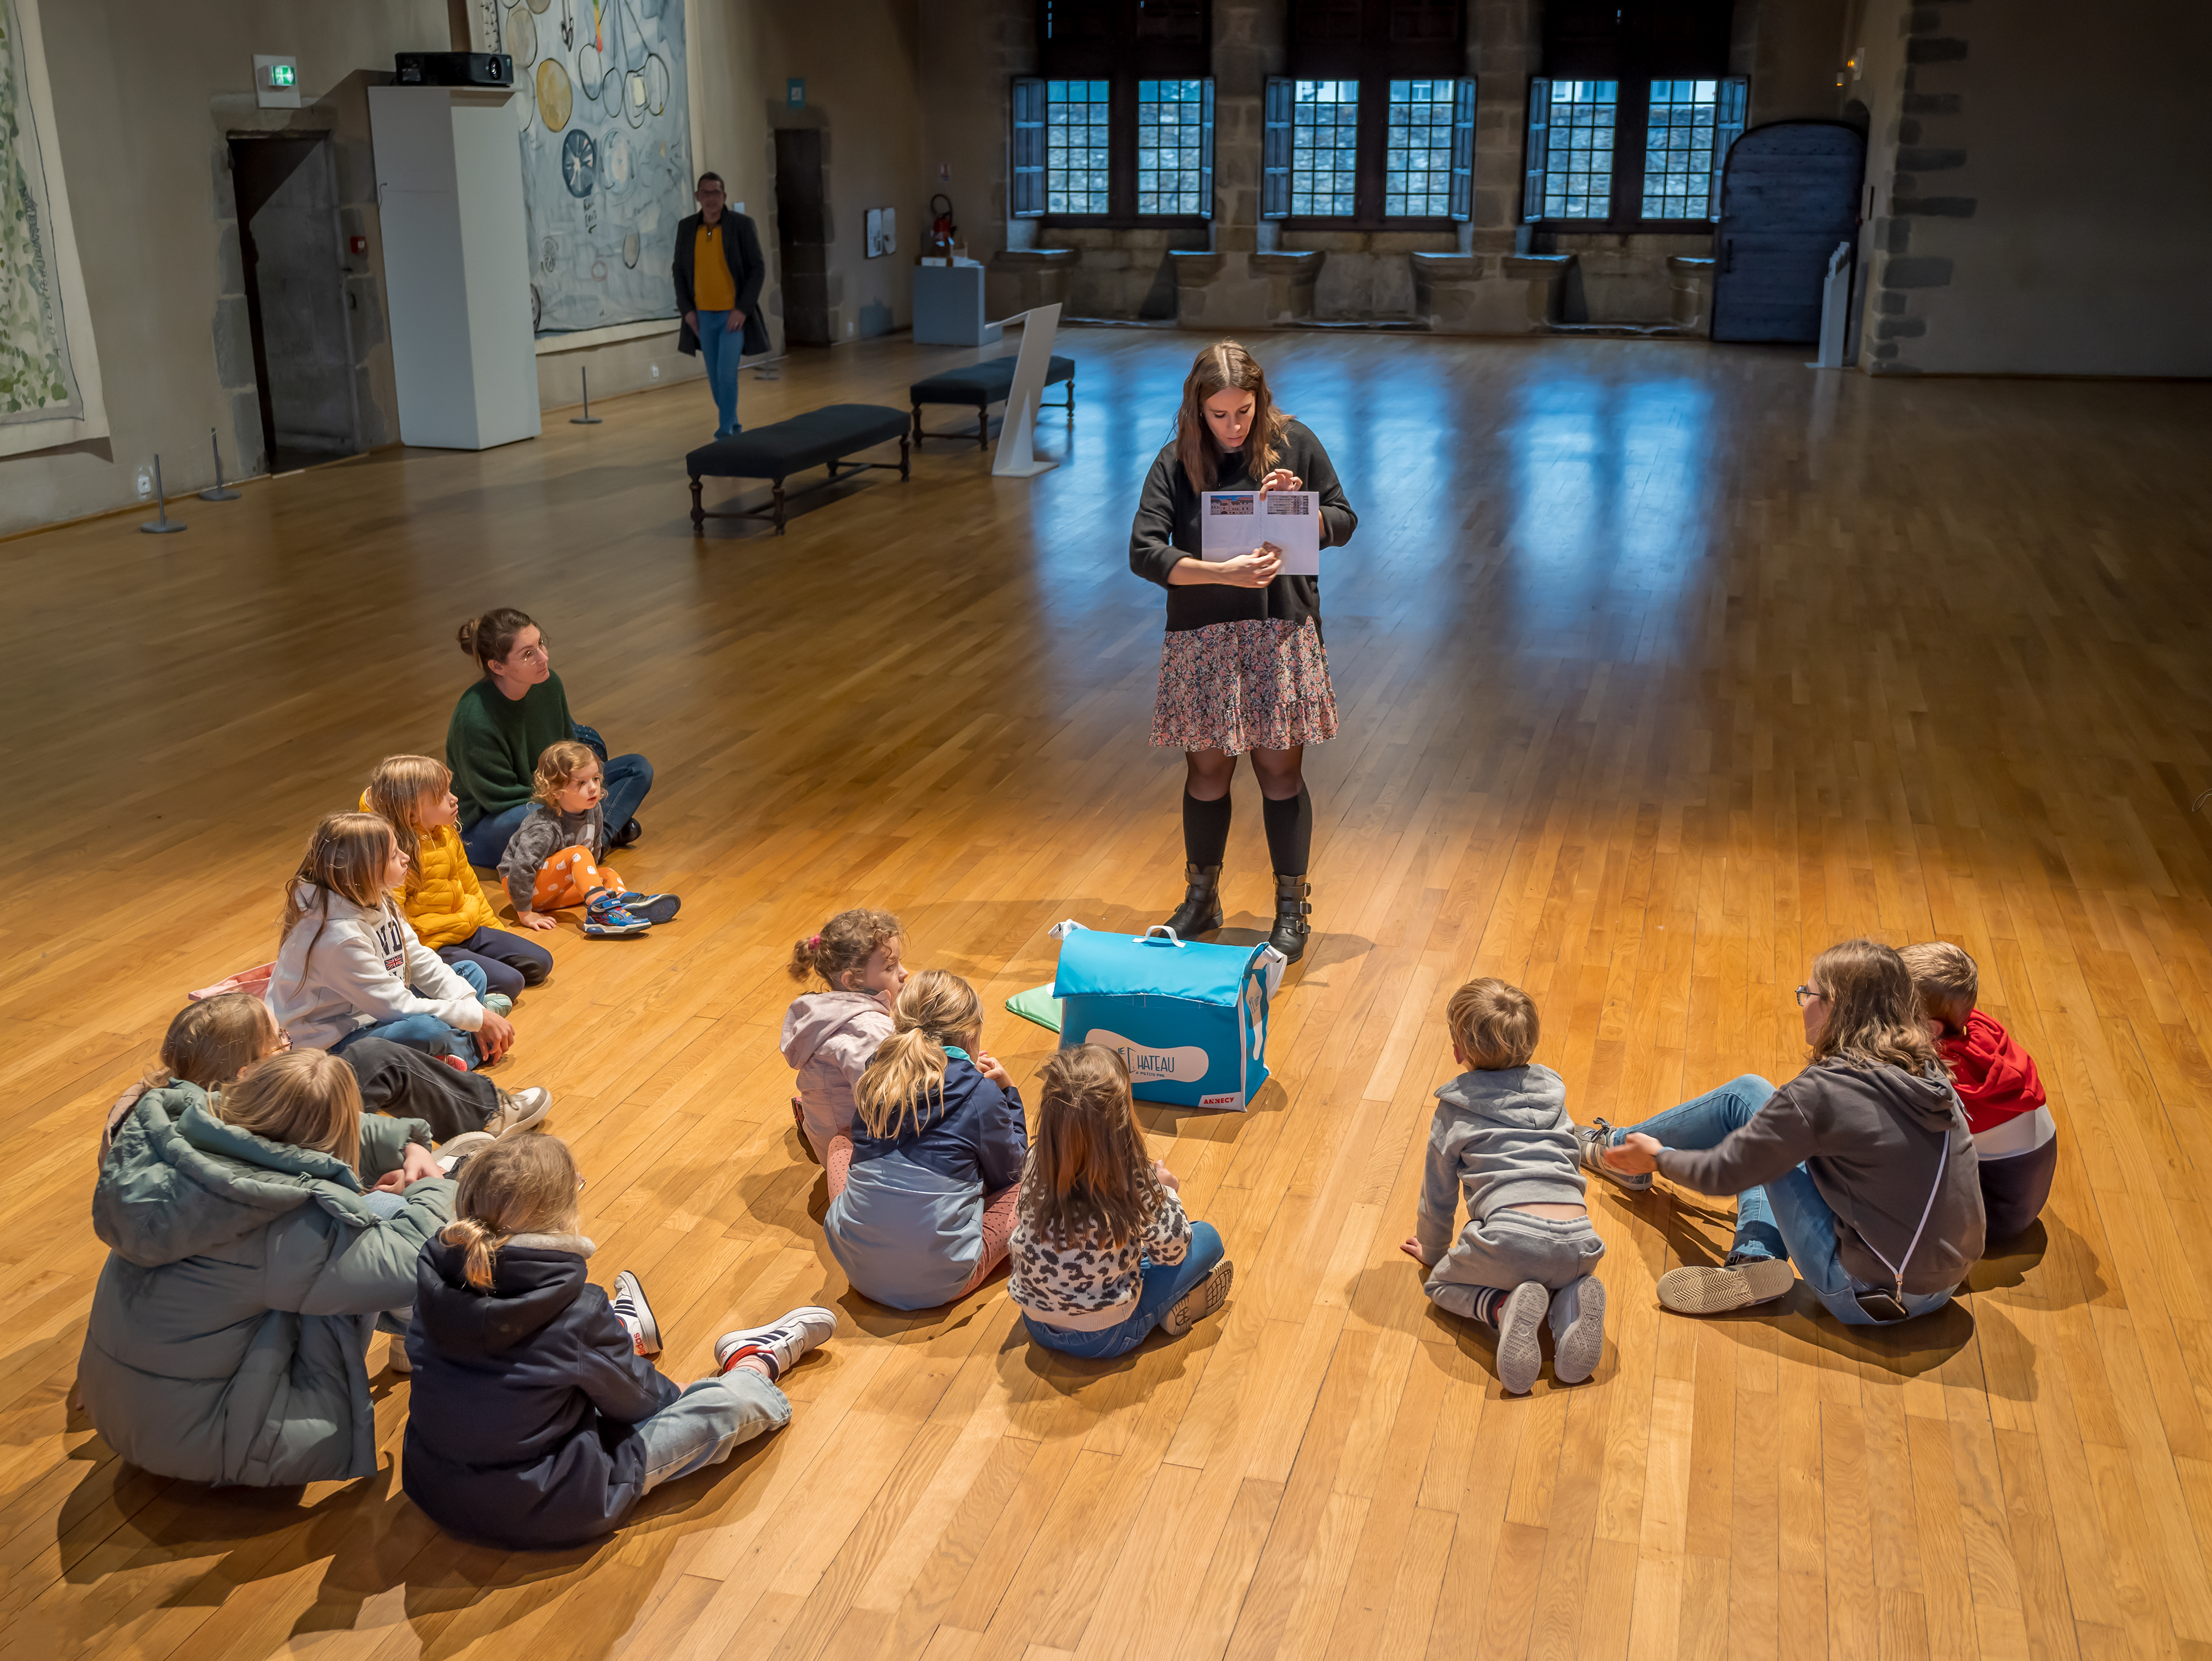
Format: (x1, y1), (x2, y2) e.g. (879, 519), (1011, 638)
(369, 86), (540, 449)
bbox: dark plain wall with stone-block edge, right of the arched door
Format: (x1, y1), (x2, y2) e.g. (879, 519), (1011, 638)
(1860, 0), (2212, 376)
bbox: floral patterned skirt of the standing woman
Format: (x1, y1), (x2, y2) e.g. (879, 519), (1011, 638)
(1152, 617), (1336, 757)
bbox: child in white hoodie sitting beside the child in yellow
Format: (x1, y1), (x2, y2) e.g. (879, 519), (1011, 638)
(268, 814), (515, 1068)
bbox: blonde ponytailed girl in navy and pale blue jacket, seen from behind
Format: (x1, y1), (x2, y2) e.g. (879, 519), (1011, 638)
(823, 969), (1029, 1309)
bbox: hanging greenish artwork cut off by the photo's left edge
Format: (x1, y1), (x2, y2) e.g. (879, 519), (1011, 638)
(0, 0), (108, 456)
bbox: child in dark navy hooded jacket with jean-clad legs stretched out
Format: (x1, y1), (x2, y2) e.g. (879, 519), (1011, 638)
(400, 1137), (836, 1550)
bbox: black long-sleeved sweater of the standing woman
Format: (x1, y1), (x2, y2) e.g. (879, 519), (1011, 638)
(1128, 420), (1360, 635)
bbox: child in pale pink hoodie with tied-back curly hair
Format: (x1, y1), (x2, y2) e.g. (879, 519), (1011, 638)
(783, 909), (907, 1168)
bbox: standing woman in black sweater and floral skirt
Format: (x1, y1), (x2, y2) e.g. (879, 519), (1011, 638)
(1128, 341), (1358, 962)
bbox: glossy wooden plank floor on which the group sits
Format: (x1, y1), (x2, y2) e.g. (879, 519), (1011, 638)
(0, 330), (2212, 1661)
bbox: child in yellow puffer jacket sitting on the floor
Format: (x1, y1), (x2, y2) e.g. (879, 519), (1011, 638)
(361, 757), (553, 1002)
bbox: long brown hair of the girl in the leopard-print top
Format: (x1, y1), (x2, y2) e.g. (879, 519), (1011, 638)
(1020, 1044), (1159, 1247)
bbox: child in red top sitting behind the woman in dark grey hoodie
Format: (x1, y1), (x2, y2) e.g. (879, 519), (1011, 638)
(1900, 940), (2059, 1245)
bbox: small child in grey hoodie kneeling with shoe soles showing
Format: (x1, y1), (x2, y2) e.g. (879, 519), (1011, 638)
(1402, 977), (1606, 1396)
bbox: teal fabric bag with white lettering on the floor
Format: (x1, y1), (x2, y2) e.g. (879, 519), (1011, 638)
(1053, 922), (1283, 1112)
